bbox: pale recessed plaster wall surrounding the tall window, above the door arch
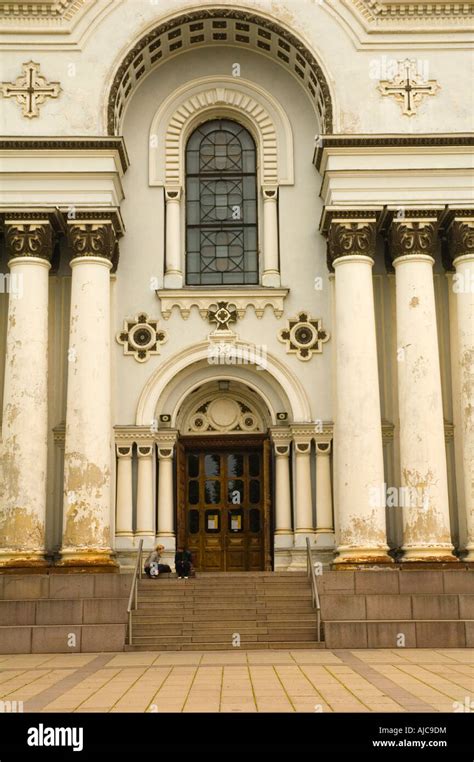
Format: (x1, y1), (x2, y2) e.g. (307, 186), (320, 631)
(113, 49), (332, 424)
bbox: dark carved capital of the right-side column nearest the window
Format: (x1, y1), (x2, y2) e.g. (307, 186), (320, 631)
(328, 211), (377, 269)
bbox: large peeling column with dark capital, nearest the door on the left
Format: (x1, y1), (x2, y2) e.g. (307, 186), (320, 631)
(59, 213), (116, 571)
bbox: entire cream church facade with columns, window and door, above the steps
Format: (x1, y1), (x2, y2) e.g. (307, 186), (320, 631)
(0, 0), (474, 572)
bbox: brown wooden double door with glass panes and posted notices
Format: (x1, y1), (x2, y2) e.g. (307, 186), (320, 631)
(177, 436), (272, 571)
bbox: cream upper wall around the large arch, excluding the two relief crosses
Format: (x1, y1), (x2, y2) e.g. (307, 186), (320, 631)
(0, 0), (473, 135)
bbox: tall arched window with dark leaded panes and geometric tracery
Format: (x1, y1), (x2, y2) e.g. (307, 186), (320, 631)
(186, 119), (258, 286)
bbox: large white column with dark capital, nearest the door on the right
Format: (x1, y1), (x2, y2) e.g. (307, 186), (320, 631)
(328, 218), (391, 565)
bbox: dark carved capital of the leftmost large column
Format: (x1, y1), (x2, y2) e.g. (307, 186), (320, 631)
(2, 209), (62, 262)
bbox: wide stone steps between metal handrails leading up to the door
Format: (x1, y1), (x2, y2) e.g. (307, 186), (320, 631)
(125, 572), (324, 651)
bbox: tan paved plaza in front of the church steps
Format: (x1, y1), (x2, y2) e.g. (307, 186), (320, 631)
(0, 649), (474, 712)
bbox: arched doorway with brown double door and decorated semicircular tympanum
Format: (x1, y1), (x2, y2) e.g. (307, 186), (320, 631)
(176, 381), (273, 571)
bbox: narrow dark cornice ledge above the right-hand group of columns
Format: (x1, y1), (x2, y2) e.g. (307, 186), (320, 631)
(313, 133), (474, 172)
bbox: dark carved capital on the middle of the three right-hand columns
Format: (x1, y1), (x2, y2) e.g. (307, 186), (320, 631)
(388, 209), (439, 261)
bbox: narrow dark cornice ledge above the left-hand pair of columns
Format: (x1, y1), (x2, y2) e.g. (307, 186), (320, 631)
(0, 136), (130, 172)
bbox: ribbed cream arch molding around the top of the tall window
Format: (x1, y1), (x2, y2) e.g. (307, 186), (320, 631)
(149, 77), (294, 188)
